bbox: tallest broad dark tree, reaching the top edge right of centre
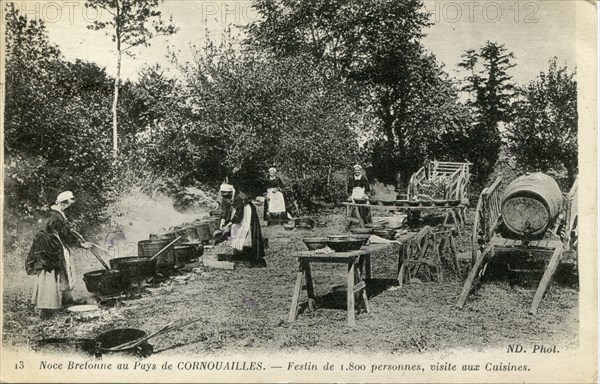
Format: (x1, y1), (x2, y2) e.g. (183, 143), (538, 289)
(248, 0), (474, 186)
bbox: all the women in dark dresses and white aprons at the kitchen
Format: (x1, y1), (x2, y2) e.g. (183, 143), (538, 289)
(26, 165), (371, 317)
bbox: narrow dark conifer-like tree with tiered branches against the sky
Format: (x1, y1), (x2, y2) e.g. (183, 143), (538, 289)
(458, 41), (515, 182)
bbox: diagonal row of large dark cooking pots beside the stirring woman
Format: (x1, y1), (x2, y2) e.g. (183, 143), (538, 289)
(83, 212), (220, 297)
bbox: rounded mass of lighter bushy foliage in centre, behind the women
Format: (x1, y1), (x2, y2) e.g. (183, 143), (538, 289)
(166, 33), (358, 204)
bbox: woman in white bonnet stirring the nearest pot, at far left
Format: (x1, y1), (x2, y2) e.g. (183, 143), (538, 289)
(26, 191), (92, 318)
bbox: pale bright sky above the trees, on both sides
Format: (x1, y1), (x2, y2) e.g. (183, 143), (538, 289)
(23, 0), (582, 83)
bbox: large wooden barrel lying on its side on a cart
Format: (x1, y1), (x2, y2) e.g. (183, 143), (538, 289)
(501, 173), (562, 239)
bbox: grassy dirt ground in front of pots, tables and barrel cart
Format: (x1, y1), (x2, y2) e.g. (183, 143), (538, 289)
(3, 207), (579, 355)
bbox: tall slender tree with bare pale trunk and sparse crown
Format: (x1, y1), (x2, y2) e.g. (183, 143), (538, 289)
(85, 0), (177, 156)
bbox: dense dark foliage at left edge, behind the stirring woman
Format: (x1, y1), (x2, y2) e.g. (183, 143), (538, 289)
(4, 4), (156, 242)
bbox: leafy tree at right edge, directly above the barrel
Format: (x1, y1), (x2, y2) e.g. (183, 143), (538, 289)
(508, 58), (578, 183)
